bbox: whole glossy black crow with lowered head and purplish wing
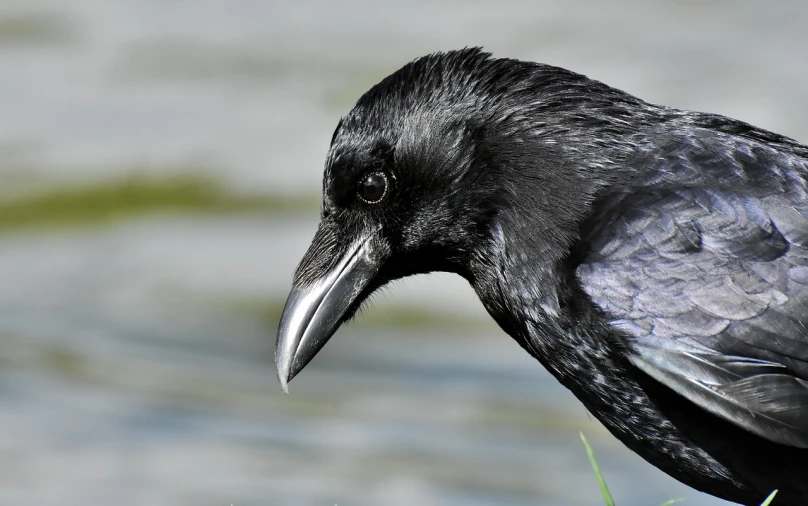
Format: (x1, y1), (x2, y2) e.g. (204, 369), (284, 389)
(275, 48), (808, 506)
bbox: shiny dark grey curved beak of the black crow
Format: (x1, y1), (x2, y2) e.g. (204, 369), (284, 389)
(275, 224), (381, 393)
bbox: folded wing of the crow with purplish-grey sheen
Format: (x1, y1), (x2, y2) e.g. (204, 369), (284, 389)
(576, 126), (808, 447)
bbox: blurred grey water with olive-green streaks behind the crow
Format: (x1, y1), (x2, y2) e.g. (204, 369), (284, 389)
(0, 0), (808, 506)
